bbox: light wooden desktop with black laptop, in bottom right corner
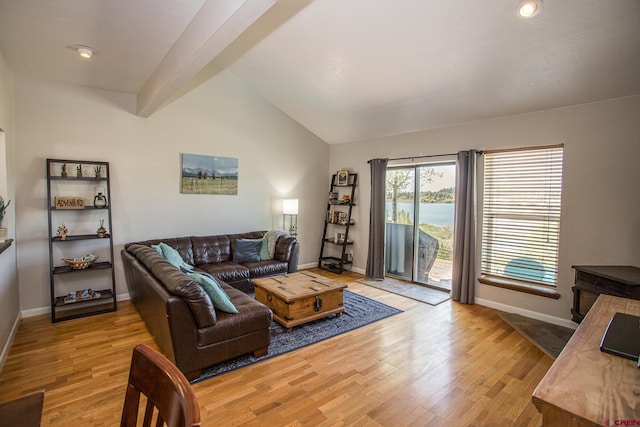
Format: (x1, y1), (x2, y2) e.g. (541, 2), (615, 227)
(533, 295), (640, 427)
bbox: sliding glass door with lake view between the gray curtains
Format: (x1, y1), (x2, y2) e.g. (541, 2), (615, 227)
(385, 163), (455, 290)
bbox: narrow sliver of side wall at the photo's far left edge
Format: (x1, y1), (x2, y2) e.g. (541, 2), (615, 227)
(0, 51), (20, 369)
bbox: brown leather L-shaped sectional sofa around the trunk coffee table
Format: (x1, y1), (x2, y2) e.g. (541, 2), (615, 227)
(121, 231), (300, 379)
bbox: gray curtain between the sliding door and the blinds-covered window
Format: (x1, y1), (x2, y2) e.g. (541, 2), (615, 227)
(451, 150), (481, 304)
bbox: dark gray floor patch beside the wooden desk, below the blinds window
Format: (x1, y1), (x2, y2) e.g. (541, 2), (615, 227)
(497, 311), (574, 360)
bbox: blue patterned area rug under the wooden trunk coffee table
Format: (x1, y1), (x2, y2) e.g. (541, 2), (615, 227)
(191, 290), (402, 384)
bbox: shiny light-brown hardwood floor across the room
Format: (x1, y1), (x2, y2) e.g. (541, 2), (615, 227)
(0, 270), (552, 426)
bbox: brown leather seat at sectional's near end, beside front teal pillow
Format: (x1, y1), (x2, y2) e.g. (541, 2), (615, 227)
(198, 283), (273, 346)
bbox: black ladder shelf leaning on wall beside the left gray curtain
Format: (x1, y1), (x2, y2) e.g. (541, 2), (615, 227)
(318, 173), (358, 274)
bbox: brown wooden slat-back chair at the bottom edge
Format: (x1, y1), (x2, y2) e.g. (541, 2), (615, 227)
(120, 344), (200, 427)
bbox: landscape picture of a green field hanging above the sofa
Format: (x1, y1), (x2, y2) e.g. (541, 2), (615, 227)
(181, 153), (238, 195)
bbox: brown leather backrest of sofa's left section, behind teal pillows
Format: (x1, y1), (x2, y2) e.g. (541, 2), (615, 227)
(127, 244), (217, 328)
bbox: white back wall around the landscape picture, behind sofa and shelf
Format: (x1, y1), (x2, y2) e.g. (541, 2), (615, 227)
(15, 73), (329, 314)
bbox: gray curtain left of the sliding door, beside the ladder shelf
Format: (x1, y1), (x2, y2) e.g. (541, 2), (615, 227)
(366, 159), (389, 279)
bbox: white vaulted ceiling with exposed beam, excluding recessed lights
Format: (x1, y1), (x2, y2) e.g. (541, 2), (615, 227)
(0, 0), (640, 144)
